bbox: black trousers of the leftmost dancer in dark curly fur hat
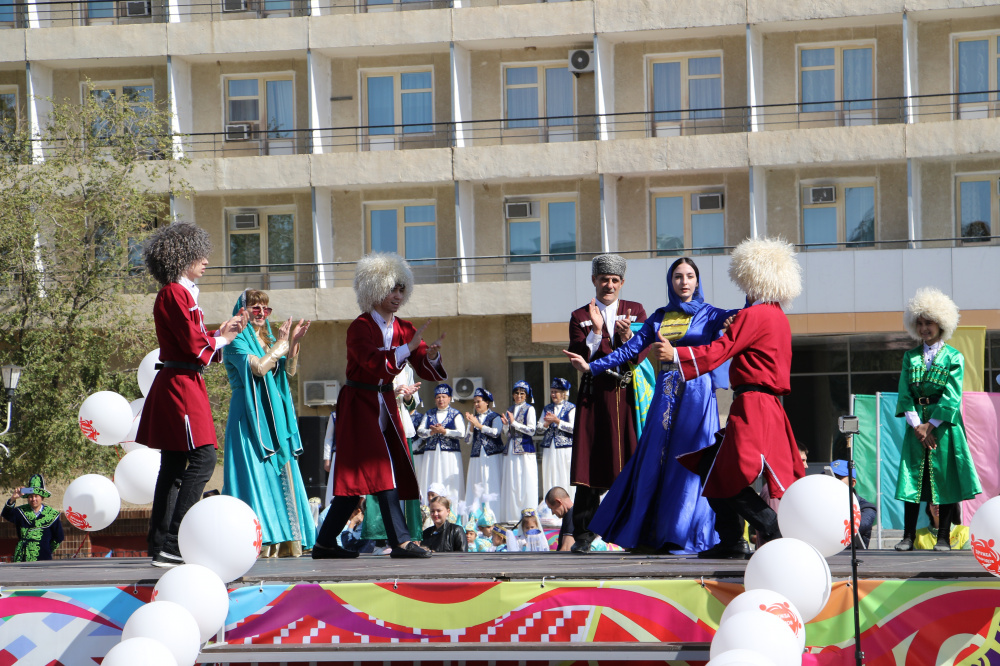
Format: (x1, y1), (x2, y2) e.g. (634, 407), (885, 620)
(146, 444), (218, 555)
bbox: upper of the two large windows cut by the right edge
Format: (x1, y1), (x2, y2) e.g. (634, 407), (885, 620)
(954, 35), (1000, 118)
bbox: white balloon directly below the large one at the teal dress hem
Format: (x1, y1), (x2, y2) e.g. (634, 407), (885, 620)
(153, 564), (229, 643)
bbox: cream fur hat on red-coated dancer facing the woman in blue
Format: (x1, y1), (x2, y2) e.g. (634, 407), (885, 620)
(729, 238), (802, 309)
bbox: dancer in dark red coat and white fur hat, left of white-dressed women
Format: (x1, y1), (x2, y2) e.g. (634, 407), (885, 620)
(312, 253), (448, 559)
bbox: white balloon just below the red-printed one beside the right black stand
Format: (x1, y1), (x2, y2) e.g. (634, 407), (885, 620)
(743, 536), (833, 622)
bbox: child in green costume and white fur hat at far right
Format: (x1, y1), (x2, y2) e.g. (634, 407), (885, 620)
(896, 287), (983, 551)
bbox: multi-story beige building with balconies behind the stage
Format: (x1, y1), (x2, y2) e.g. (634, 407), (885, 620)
(0, 0), (1000, 460)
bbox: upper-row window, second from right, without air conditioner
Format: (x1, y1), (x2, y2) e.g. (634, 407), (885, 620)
(799, 44), (875, 125)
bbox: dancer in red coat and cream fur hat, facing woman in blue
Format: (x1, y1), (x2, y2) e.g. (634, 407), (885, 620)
(650, 238), (805, 558)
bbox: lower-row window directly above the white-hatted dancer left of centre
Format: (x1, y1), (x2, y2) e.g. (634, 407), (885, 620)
(368, 202), (437, 266)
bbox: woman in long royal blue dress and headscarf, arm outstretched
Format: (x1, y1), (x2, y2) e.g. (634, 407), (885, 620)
(567, 257), (735, 553)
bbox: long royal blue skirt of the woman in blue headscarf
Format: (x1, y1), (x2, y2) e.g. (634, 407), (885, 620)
(590, 371), (719, 553)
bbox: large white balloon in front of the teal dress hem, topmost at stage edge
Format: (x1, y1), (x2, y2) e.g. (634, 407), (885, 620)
(177, 495), (262, 583)
